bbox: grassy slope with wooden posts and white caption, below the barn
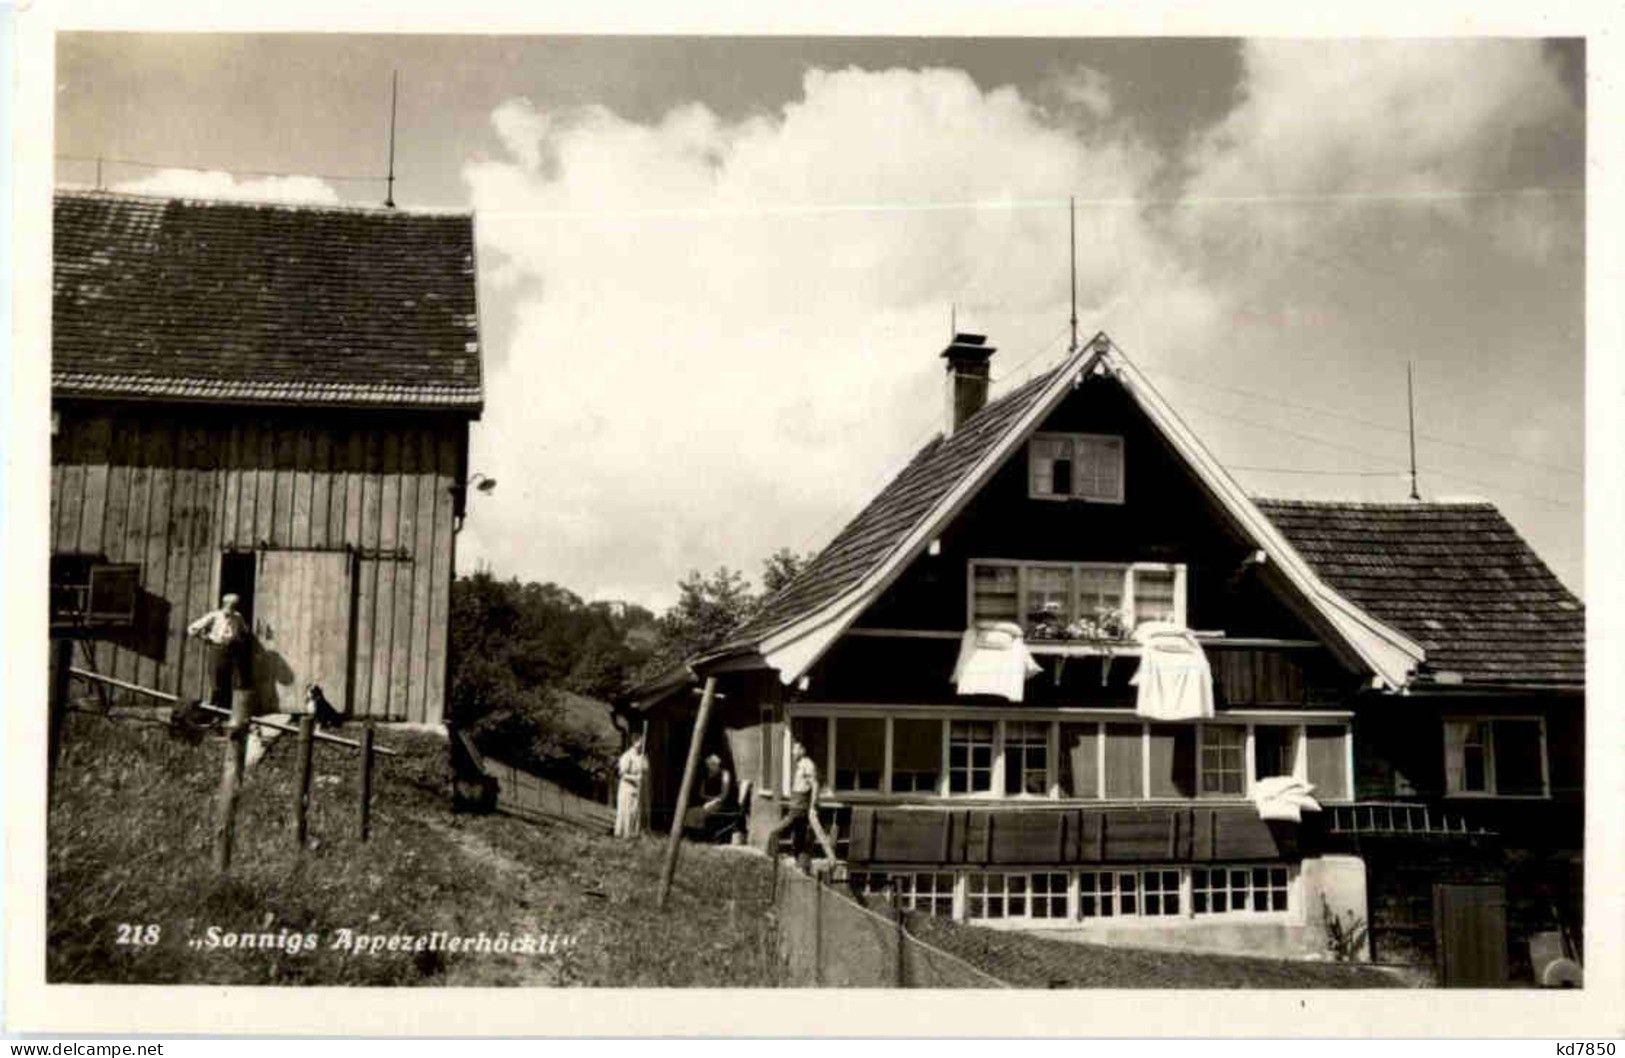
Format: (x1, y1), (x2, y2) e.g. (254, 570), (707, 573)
(47, 715), (775, 986)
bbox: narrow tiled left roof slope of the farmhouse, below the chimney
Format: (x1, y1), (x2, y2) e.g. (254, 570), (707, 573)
(731, 364), (1064, 642)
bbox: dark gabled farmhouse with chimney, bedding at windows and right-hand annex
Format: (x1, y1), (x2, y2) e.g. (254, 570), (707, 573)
(634, 335), (1584, 982)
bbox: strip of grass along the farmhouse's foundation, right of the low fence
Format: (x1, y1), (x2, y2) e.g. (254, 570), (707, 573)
(908, 917), (1401, 988)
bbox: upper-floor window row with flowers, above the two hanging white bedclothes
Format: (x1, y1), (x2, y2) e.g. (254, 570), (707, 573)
(970, 561), (1185, 634)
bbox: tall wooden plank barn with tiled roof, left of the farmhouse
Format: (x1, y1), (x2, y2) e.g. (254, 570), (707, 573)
(50, 192), (483, 723)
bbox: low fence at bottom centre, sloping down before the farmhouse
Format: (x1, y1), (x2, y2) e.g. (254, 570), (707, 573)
(774, 869), (1009, 988)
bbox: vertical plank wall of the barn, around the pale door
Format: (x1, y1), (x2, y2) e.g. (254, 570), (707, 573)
(50, 406), (468, 723)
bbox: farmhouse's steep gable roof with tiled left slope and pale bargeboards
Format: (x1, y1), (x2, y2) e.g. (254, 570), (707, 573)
(692, 335), (1424, 687)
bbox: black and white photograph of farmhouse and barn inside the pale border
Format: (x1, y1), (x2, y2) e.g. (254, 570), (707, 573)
(7, 6), (1617, 1034)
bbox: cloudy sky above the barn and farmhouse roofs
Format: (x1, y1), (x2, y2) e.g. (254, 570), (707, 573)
(55, 34), (1584, 606)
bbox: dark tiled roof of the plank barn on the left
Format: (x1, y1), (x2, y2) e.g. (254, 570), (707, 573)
(52, 192), (481, 413)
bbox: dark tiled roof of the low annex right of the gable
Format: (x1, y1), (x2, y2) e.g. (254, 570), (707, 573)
(1255, 499), (1586, 684)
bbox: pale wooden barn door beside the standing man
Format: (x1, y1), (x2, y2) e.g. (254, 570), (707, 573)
(254, 551), (354, 712)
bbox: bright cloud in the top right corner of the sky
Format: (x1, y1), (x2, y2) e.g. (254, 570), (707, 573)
(1177, 39), (1575, 260)
